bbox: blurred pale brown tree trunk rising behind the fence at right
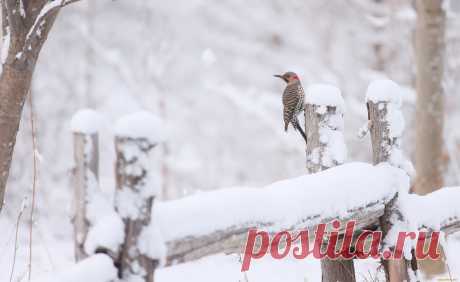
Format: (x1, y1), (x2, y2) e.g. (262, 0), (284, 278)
(414, 0), (445, 195)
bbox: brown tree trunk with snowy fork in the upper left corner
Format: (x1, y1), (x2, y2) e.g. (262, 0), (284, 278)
(0, 0), (61, 211)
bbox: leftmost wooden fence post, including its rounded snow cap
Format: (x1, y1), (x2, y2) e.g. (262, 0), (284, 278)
(71, 109), (99, 261)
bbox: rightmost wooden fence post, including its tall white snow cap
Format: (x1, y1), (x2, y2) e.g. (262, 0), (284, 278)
(366, 80), (416, 282)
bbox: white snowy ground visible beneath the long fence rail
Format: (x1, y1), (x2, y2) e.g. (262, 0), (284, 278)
(155, 254), (385, 282)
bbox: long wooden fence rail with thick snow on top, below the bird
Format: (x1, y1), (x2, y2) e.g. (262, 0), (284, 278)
(158, 163), (409, 264)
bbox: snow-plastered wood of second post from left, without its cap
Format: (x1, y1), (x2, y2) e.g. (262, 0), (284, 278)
(115, 136), (158, 282)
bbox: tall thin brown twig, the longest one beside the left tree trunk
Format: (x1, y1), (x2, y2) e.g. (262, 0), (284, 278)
(28, 90), (37, 282)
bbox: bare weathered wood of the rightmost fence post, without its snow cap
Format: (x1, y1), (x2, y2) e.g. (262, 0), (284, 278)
(367, 100), (416, 282)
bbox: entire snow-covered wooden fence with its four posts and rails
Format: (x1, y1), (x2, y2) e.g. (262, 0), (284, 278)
(68, 81), (460, 282)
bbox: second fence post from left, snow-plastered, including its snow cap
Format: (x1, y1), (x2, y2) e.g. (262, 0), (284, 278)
(115, 112), (161, 282)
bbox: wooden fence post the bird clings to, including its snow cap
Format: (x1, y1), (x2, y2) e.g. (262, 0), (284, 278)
(305, 84), (356, 282)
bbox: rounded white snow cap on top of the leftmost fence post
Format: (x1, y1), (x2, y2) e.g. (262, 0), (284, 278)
(70, 109), (102, 134)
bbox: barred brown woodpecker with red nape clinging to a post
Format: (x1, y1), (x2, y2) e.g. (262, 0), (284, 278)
(274, 71), (308, 144)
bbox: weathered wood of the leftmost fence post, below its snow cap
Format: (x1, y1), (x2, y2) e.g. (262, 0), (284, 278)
(72, 132), (99, 261)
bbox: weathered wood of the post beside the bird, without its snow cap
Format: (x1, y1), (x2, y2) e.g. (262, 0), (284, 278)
(305, 91), (356, 282)
